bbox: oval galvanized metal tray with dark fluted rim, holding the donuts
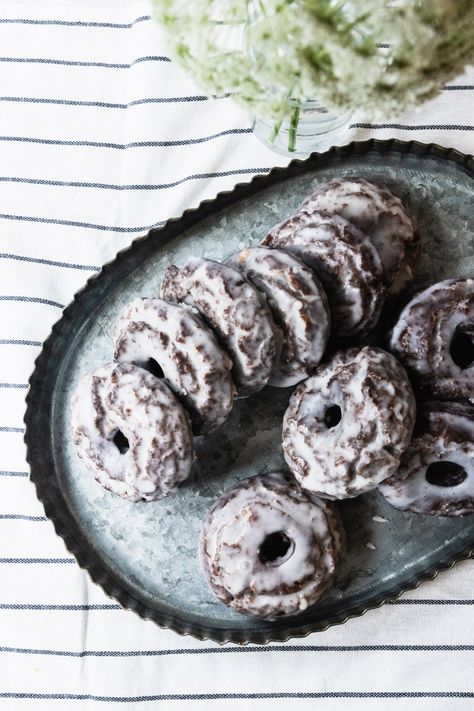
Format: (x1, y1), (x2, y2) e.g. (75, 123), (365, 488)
(25, 141), (474, 643)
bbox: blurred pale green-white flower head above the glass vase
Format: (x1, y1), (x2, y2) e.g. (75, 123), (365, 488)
(154, 0), (474, 121)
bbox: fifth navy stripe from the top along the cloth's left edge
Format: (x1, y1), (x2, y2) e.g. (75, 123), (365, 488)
(0, 168), (269, 195)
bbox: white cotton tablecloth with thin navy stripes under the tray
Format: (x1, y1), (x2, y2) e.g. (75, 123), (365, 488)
(0, 0), (474, 711)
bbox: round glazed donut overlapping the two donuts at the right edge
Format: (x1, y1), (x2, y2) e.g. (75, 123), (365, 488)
(283, 346), (415, 499)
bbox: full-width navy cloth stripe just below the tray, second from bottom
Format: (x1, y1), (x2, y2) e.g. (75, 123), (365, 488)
(0, 644), (474, 659)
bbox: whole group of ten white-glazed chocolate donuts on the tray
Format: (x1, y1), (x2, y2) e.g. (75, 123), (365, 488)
(72, 178), (474, 620)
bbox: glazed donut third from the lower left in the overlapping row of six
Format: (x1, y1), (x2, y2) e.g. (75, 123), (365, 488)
(161, 257), (281, 396)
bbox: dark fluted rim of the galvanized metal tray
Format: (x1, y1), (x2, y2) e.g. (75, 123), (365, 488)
(24, 139), (474, 645)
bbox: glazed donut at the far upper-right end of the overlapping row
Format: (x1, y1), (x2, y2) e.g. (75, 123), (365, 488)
(299, 178), (416, 291)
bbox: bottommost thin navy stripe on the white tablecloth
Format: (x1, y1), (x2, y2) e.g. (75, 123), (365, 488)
(0, 691), (474, 703)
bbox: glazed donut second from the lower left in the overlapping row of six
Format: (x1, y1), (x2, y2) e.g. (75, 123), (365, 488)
(114, 298), (234, 434)
